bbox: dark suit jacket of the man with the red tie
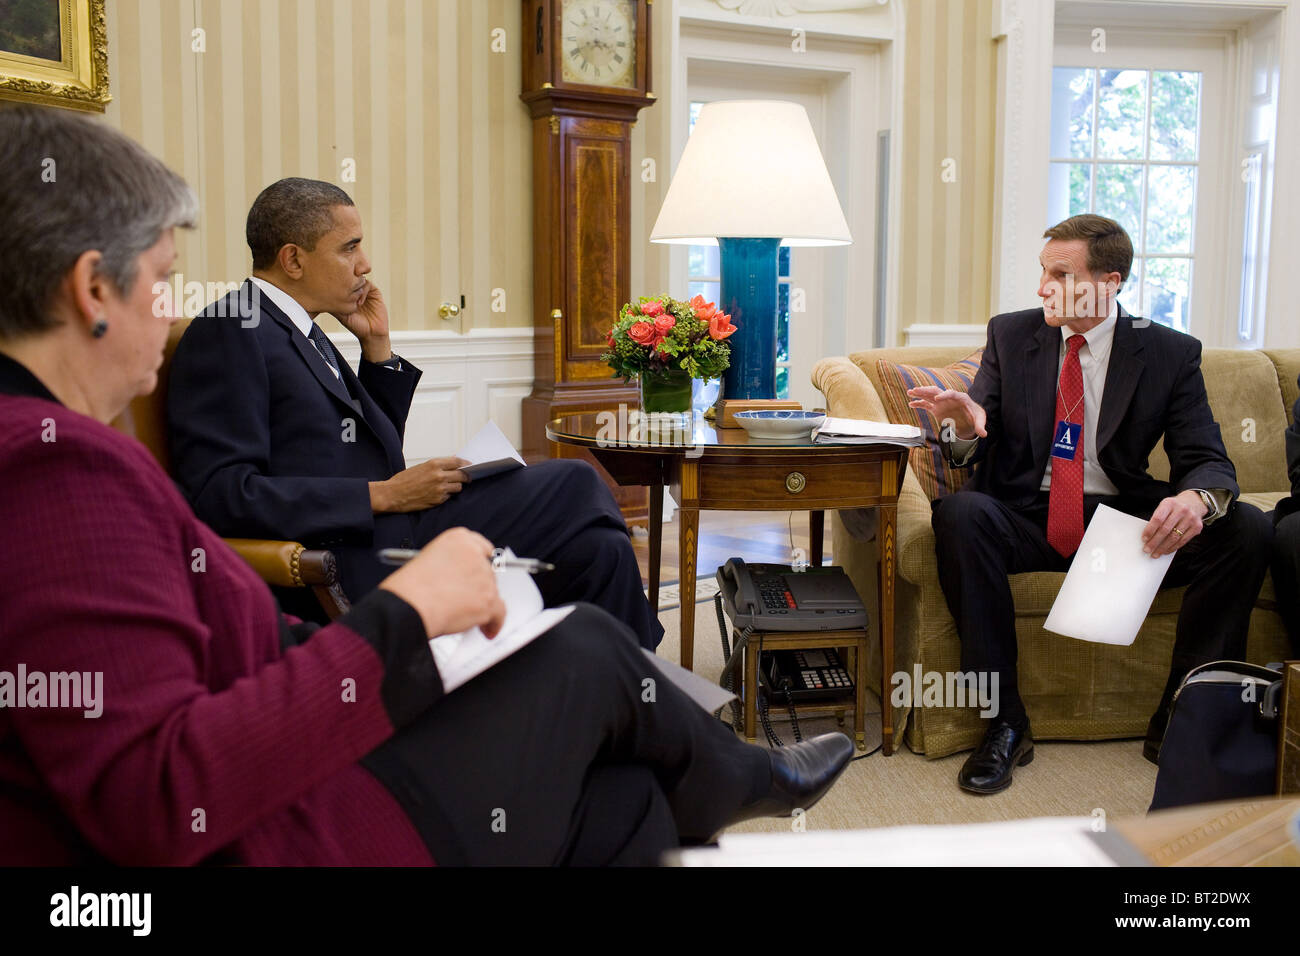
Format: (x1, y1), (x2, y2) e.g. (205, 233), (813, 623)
(962, 308), (1238, 507)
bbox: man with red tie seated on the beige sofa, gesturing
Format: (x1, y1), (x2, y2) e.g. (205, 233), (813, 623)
(909, 215), (1271, 793)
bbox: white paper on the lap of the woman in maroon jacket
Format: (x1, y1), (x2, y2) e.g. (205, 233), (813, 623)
(429, 548), (573, 693)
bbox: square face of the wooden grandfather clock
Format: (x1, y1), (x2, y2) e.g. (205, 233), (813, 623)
(560, 0), (637, 90)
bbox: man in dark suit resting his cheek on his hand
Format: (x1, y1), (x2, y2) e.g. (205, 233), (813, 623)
(168, 179), (663, 649)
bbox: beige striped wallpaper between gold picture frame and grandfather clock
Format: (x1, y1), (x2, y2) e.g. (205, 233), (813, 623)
(108, 0), (532, 330)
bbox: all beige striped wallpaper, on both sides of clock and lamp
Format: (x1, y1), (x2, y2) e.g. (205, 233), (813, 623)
(108, 0), (996, 332)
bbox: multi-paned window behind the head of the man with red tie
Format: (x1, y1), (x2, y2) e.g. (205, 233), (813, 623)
(1048, 66), (1201, 332)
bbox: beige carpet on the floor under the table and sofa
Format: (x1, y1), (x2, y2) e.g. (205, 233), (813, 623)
(659, 600), (1156, 832)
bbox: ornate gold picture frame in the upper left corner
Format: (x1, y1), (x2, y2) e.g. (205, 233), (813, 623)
(0, 0), (112, 113)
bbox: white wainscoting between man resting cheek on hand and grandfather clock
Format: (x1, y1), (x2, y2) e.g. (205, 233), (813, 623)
(330, 329), (533, 466)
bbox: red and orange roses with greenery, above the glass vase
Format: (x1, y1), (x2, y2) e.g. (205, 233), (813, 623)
(601, 295), (736, 378)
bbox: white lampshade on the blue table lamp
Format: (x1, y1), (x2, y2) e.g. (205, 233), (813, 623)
(650, 100), (853, 246)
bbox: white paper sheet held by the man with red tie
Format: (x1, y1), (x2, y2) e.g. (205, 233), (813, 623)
(1043, 505), (1174, 646)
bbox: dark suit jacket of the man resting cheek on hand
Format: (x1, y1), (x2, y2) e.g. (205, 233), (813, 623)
(166, 282), (421, 597)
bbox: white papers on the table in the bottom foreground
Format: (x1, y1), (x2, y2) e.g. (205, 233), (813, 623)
(676, 817), (1118, 869)
